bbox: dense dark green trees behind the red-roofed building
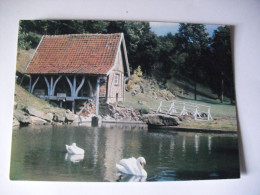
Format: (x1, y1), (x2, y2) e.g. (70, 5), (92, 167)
(18, 20), (234, 100)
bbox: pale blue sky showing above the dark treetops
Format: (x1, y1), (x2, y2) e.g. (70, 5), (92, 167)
(150, 22), (220, 36)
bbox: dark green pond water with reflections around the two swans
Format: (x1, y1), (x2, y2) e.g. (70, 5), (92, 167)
(10, 124), (240, 182)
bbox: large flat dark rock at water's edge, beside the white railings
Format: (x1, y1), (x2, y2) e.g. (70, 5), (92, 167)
(143, 114), (180, 126)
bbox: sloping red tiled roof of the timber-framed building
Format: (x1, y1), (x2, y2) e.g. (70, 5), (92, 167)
(26, 33), (122, 75)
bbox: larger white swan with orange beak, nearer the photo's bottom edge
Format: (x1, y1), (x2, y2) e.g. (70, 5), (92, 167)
(116, 157), (147, 177)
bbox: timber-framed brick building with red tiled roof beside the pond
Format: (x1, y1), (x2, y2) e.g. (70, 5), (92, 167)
(25, 33), (130, 114)
